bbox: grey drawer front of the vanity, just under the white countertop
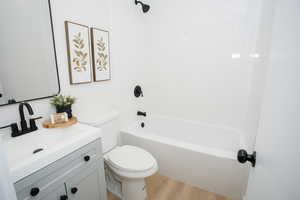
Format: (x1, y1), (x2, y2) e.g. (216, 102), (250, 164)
(15, 139), (102, 200)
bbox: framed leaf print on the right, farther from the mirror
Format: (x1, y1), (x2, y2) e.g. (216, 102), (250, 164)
(91, 28), (111, 81)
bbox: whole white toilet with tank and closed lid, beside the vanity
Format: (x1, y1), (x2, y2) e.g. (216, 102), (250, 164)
(81, 111), (158, 200)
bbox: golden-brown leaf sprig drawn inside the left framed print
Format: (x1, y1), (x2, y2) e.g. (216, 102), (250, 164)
(73, 32), (88, 72)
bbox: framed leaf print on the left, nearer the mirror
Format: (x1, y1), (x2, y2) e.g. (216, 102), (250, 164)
(65, 21), (92, 84)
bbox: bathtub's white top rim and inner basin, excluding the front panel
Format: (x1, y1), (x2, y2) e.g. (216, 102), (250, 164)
(121, 115), (245, 160)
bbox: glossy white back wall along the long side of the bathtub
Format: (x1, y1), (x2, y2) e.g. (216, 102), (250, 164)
(142, 0), (268, 148)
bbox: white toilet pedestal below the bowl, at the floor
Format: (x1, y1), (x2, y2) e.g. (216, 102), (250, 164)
(122, 179), (147, 200)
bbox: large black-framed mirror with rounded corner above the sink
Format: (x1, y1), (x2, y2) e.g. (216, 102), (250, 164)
(0, 0), (60, 106)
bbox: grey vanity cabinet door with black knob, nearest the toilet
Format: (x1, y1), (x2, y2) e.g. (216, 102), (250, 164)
(66, 161), (106, 200)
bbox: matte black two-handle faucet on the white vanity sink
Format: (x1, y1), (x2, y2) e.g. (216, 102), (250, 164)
(0, 102), (42, 137)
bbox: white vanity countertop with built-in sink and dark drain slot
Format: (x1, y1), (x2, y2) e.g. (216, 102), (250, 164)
(2, 123), (101, 182)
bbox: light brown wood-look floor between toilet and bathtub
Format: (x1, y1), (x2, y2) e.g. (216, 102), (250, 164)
(108, 174), (229, 200)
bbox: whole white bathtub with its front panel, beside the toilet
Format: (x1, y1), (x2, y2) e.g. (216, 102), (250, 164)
(120, 116), (249, 200)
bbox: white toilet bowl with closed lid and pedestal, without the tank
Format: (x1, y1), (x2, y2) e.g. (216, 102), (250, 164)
(104, 145), (158, 200)
